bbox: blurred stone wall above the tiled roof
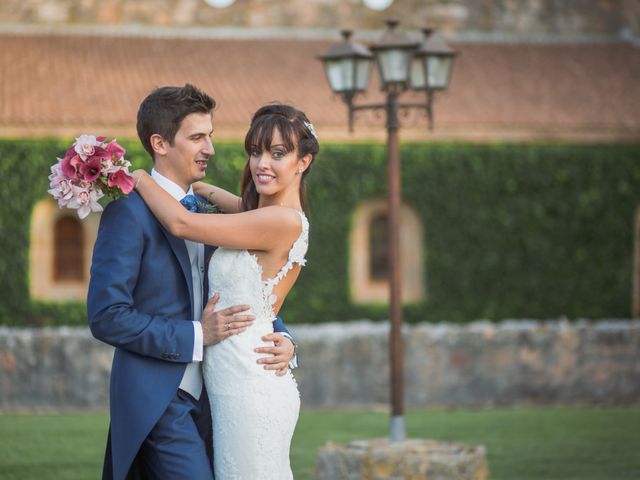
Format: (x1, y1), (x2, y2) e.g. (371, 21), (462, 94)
(0, 0), (640, 35)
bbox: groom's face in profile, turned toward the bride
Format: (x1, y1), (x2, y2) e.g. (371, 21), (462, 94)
(157, 113), (215, 191)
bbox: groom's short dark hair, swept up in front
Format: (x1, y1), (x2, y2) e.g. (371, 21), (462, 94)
(136, 83), (216, 162)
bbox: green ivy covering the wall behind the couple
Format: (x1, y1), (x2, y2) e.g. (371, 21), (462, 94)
(0, 139), (640, 325)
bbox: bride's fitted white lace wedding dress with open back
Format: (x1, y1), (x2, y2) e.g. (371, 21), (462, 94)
(203, 213), (309, 480)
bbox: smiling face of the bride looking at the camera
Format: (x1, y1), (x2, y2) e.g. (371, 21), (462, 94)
(249, 128), (304, 196)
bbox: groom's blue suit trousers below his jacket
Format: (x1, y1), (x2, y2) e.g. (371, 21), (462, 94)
(137, 390), (213, 480)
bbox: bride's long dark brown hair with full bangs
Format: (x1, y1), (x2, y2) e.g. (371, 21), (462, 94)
(240, 103), (320, 210)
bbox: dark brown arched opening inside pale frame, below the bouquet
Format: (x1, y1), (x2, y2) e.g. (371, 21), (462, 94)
(53, 216), (84, 282)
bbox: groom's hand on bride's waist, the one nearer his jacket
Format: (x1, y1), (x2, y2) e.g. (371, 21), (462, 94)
(200, 293), (256, 346)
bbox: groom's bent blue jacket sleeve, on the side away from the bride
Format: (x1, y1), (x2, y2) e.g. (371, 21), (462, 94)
(87, 200), (194, 362)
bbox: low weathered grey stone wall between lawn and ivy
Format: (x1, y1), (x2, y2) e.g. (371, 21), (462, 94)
(0, 321), (640, 410)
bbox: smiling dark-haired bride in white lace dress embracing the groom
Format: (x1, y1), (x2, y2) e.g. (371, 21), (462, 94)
(134, 104), (319, 480)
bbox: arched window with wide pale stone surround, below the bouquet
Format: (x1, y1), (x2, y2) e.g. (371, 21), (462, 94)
(29, 198), (100, 301)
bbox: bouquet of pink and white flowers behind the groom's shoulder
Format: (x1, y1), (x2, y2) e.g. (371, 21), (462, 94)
(49, 135), (135, 218)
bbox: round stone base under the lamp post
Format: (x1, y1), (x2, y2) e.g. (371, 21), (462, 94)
(315, 439), (489, 480)
